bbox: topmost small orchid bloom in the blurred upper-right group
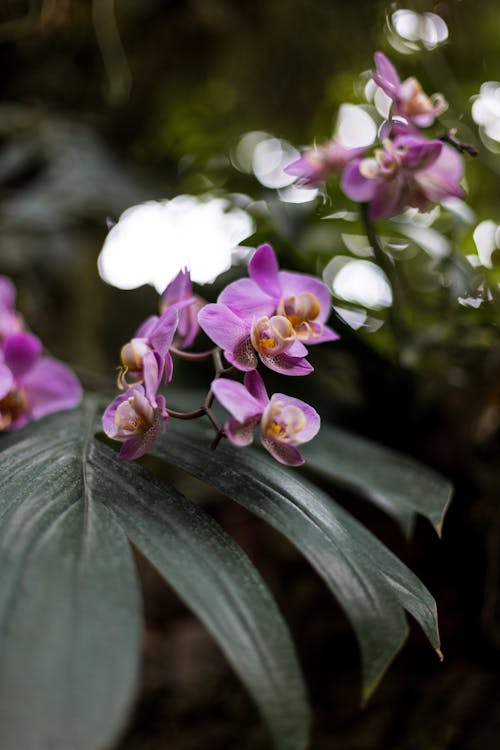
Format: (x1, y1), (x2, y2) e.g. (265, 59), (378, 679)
(372, 52), (448, 128)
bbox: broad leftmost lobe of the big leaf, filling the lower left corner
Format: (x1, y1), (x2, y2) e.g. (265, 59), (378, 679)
(0, 408), (140, 750)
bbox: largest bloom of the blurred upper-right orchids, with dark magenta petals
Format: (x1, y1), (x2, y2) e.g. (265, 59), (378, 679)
(342, 125), (464, 221)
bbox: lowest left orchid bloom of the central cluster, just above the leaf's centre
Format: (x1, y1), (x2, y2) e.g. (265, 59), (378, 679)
(102, 385), (167, 461)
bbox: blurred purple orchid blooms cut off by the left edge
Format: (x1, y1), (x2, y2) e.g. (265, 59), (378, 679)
(0, 276), (82, 431)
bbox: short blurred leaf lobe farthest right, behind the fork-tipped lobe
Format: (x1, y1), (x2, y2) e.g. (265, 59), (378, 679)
(301, 425), (453, 535)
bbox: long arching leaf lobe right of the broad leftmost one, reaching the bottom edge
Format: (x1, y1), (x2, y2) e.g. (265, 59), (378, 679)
(91, 446), (309, 750)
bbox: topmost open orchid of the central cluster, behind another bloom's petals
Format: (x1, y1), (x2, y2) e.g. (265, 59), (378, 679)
(218, 245), (338, 348)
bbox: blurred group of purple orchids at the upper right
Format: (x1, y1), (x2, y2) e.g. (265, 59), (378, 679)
(286, 52), (464, 221)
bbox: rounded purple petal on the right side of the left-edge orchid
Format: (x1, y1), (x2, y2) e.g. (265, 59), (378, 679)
(19, 357), (82, 419)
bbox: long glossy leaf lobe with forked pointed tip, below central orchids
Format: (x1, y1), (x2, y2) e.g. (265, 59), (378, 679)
(153, 423), (439, 698)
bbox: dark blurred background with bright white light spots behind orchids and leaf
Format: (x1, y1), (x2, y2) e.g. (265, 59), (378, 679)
(0, 0), (500, 750)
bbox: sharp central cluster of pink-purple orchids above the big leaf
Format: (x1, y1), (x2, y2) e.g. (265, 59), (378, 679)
(103, 245), (338, 466)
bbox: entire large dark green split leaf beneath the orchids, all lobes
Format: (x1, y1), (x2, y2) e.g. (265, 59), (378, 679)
(0, 400), (449, 750)
